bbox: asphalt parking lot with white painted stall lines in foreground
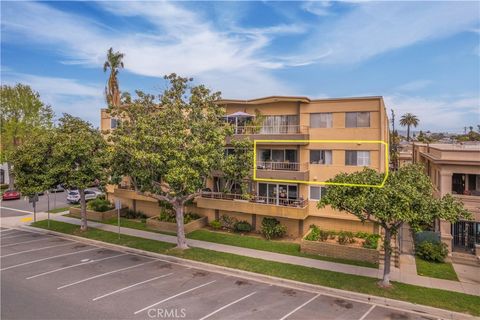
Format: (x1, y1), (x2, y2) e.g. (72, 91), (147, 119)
(0, 228), (436, 320)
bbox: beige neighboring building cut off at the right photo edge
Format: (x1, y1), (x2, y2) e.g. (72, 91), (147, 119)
(413, 143), (480, 255)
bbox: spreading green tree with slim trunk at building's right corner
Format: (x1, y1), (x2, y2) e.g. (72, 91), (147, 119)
(318, 165), (470, 286)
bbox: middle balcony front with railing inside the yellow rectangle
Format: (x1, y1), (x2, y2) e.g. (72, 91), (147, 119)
(256, 161), (309, 181)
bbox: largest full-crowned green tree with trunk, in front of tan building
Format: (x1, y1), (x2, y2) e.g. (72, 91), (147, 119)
(111, 74), (230, 249)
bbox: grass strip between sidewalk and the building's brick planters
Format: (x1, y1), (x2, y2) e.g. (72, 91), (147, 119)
(187, 230), (378, 269)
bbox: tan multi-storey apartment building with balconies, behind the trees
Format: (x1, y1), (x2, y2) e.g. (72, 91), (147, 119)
(101, 96), (388, 237)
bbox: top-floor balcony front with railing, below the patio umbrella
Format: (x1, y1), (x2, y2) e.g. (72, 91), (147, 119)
(232, 125), (309, 145)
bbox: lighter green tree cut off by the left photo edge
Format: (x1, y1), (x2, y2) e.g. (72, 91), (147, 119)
(0, 83), (53, 189)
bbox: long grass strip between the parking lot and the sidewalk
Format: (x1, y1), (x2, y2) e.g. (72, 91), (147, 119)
(32, 221), (480, 316)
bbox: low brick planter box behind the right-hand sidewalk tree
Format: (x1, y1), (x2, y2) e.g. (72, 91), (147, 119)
(300, 232), (380, 263)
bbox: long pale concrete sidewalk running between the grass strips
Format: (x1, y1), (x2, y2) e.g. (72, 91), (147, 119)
(5, 215), (480, 296)
